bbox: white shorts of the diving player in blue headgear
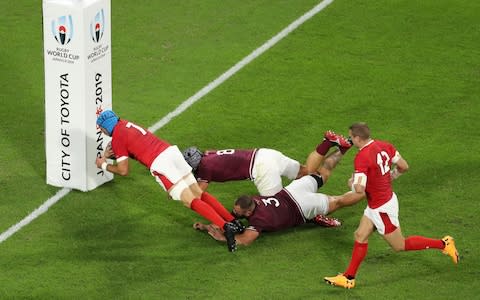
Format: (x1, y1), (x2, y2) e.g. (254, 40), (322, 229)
(150, 145), (196, 200)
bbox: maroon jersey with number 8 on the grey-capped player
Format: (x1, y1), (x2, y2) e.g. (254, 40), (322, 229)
(195, 149), (257, 182)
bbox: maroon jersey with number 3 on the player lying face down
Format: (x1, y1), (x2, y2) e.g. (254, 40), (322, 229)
(248, 189), (305, 233)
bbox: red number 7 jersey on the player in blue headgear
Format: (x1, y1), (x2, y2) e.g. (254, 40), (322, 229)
(112, 120), (170, 169)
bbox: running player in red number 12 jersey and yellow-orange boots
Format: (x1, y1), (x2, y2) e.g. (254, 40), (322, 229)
(324, 123), (458, 289)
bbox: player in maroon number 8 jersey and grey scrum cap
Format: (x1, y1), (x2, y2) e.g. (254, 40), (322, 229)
(183, 131), (351, 196)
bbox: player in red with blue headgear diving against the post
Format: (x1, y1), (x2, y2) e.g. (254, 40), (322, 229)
(96, 110), (243, 251)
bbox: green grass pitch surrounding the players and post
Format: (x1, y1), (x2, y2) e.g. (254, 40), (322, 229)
(0, 0), (480, 299)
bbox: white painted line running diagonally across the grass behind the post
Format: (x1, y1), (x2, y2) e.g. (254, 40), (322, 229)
(0, 0), (334, 243)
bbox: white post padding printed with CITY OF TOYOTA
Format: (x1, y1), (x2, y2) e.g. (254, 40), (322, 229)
(43, 0), (113, 191)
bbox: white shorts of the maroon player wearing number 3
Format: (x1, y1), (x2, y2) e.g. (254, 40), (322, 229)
(285, 176), (328, 220)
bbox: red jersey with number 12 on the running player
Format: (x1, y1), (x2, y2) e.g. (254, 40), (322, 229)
(354, 140), (400, 208)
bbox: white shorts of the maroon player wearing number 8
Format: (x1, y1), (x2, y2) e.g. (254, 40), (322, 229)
(252, 148), (300, 196)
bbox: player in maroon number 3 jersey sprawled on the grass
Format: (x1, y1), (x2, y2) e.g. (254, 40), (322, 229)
(194, 151), (350, 245)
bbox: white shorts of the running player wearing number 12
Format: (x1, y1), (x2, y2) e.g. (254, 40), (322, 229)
(363, 193), (400, 235)
